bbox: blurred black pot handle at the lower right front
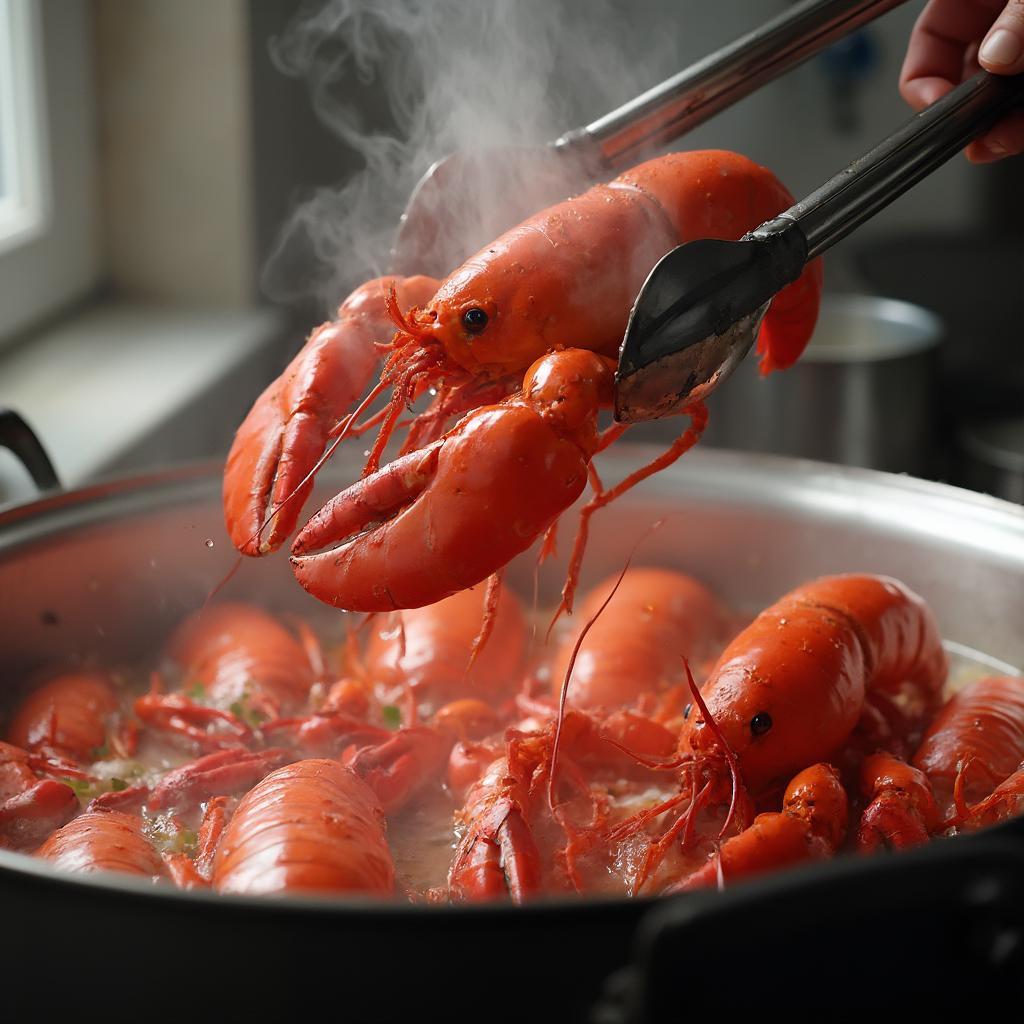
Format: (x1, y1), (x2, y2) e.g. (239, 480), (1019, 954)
(590, 834), (1024, 1024)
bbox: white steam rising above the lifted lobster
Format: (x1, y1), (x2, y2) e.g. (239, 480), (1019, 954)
(263, 0), (680, 312)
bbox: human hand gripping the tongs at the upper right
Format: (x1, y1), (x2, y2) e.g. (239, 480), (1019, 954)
(899, 0), (1024, 164)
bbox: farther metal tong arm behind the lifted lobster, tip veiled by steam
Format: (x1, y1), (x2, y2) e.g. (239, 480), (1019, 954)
(391, 0), (906, 276)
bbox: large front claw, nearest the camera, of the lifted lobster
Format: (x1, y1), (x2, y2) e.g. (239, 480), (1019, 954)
(292, 403), (587, 611)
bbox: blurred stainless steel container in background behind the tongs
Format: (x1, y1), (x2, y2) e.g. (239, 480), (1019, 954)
(640, 295), (942, 474)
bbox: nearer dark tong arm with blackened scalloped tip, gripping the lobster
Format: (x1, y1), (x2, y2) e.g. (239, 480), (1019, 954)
(615, 72), (1024, 423)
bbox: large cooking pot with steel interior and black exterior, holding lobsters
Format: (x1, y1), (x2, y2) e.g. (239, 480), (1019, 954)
(0, 446), (1024, 1021)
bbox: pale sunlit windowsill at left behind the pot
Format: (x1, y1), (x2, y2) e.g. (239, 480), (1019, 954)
(0, 301), (287, 505)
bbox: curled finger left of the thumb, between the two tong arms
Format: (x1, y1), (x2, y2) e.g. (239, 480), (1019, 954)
(899, 0), (1003, 110)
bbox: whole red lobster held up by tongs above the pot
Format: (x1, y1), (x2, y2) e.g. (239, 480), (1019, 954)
(224, 151), (821, 611)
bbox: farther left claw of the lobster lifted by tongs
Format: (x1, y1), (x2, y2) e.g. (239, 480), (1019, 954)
(224, 276), (437, 556)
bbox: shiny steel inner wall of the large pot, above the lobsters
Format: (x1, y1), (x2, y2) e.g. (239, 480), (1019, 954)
(0, 445), (1024, 681)
